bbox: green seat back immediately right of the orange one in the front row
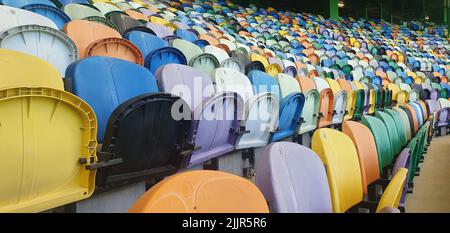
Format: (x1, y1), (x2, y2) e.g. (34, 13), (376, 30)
(361, 115), (394, 175)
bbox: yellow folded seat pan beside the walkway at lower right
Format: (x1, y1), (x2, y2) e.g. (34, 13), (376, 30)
(376, 168), (408, 213)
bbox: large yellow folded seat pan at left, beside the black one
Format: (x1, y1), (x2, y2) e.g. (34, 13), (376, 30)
(0, 87), (97, 212)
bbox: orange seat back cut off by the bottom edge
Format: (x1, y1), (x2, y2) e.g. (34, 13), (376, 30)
(128, 170), (269, 213)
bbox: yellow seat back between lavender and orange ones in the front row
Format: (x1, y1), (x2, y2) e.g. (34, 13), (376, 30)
(312, 128), (363, 213)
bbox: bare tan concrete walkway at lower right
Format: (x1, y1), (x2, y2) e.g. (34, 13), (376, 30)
(405, 136), (450, 213)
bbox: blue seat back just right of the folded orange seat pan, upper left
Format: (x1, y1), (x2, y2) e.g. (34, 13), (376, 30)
(125, 31), (169, 57)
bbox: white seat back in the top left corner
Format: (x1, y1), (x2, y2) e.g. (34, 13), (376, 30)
(0, 5), (58, 32)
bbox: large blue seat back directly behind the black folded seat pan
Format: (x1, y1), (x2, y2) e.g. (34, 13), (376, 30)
(66, 57), (158, 143)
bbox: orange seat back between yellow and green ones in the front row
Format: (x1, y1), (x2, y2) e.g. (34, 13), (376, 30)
(342, 121), (380, 194)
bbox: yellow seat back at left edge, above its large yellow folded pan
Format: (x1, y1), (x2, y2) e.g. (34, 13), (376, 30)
(0, 49), (64, 90)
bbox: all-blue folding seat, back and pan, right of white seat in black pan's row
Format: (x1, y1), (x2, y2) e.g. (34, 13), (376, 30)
(248, 70), (305, 141)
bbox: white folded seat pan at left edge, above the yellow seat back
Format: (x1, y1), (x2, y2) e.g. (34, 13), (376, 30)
(0, 25), (78, 77)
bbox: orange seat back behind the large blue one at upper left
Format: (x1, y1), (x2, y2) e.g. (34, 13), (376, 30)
(63, 20), (122, 59)
